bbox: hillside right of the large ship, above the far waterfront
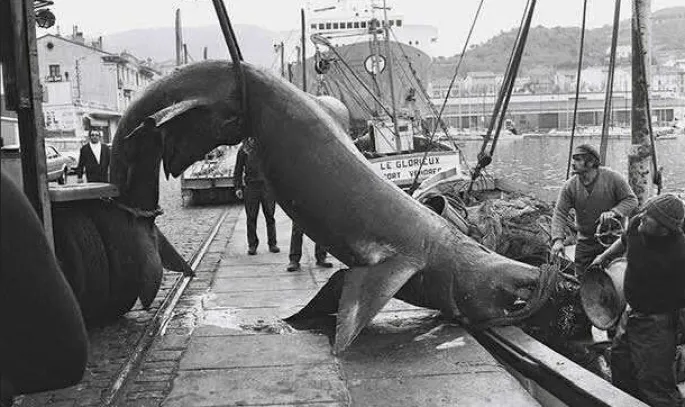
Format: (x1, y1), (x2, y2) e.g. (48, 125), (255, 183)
(432, 7), (685, 78)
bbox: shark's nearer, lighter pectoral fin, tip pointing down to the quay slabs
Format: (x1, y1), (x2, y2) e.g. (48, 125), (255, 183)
(333, 255), (421, 354)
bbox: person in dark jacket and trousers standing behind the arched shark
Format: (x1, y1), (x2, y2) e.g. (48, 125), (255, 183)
(233, 138), (281, 255)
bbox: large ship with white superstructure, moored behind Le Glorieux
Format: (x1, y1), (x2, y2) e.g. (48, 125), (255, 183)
(291, 0), (438, 135)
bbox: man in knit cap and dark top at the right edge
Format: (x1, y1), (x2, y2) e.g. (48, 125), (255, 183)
(592, 194), (685, 406)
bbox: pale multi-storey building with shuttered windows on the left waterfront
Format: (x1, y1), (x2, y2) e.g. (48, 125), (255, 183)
(37, 27), (159, 143)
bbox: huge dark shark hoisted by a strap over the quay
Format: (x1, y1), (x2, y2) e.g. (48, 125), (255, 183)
(117, 61), (554, 353)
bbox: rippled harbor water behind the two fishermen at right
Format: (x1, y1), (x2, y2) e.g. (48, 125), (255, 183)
(458, 136), (685, 202)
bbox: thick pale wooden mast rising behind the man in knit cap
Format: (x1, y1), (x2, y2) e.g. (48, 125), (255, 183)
(628, 0), (653, 203)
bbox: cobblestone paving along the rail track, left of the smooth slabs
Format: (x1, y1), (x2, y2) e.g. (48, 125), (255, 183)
(14, 178), (242, 407)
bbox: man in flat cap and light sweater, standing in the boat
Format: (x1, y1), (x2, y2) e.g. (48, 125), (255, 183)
(552, 144), (638, 336)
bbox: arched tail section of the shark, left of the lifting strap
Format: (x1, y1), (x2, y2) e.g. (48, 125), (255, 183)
(111, 61), (250, 207)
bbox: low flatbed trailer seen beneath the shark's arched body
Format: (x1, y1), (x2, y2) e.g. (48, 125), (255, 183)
(181, 146), (239, 205)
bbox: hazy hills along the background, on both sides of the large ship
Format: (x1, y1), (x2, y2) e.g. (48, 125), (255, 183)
(104, 7), (685, 78)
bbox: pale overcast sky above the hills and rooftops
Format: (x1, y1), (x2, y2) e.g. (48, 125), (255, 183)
(39, 0), (685, 56)
